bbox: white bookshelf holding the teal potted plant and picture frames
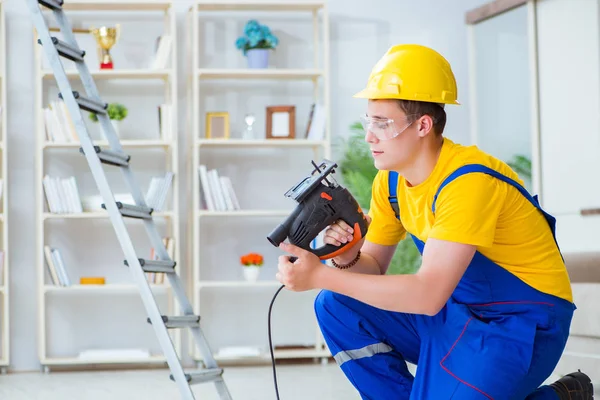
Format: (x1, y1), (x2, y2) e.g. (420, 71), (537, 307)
(186, 0), (331, 363)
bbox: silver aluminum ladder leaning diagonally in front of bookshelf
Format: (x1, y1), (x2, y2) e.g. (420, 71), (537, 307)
(27, 0), (231, 400)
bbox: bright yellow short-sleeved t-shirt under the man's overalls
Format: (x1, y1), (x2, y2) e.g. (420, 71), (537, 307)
(366, 138), (573, 301)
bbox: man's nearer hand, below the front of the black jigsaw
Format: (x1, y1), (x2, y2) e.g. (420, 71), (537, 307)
(276, 243), (327, 292)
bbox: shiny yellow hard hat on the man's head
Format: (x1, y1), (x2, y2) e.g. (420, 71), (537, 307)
(353, 44), (460, 104)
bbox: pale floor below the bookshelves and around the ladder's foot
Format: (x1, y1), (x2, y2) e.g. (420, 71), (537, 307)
(0, 364), (360, 400)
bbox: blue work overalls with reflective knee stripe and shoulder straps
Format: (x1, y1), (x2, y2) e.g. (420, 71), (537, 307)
(315, 164), (575, 400)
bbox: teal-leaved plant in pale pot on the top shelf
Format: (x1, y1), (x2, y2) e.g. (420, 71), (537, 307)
(235, 19), (279, 68)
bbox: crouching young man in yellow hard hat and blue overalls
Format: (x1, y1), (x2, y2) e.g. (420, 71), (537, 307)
(277, 45), (593, 400)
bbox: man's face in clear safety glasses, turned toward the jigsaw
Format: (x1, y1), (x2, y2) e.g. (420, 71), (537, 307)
(363, 100), (419, 170)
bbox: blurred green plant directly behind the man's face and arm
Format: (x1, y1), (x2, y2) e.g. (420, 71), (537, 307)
(338, 122), (421, 275)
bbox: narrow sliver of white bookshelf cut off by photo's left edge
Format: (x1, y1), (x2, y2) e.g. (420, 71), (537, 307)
(0, 0), (10, 373)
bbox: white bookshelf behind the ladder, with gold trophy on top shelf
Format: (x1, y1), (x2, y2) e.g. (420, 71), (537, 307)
(34, 0), (181, 371)
